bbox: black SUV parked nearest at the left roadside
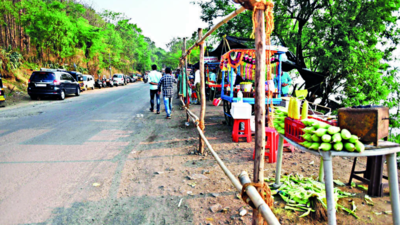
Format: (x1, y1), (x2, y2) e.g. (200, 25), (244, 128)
(28, 71), (81, 100)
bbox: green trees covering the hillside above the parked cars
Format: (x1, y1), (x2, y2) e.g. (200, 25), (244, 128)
(0, 0), (179, 74)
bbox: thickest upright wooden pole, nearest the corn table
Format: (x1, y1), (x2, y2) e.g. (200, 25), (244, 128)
(253, 9), (266, 225)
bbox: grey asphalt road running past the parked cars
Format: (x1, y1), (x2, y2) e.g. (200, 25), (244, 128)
(0, 83), (181, 224)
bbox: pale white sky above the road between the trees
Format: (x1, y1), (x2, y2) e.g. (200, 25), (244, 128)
(92, 0), (208, 50)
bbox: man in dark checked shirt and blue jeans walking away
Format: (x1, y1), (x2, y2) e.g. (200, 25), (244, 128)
(157, 67), (176, 119)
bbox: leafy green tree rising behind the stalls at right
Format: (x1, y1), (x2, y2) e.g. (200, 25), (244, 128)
(197, 0), (400, 106)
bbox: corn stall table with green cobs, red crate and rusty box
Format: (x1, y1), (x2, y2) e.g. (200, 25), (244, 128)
(273, 98), (400, 224)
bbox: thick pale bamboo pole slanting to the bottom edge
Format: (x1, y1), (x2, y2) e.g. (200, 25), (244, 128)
(239, 171), (280, 225)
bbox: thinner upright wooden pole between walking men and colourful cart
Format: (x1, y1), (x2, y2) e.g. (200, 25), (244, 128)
(198, 28), (206, 155)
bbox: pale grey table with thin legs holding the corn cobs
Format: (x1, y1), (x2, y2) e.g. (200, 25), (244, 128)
(273, 134), (400, 225)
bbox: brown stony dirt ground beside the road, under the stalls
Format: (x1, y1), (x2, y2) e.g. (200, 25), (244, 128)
(127, 99), (392, 224)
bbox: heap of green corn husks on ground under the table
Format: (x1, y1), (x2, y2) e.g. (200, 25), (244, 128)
(265, 175), (358, 219)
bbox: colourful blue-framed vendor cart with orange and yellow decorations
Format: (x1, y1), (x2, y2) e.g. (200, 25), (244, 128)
(220, 46), (288, 126)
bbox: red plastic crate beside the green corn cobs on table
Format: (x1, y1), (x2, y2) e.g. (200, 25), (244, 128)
(285, 116), (337, 142)
